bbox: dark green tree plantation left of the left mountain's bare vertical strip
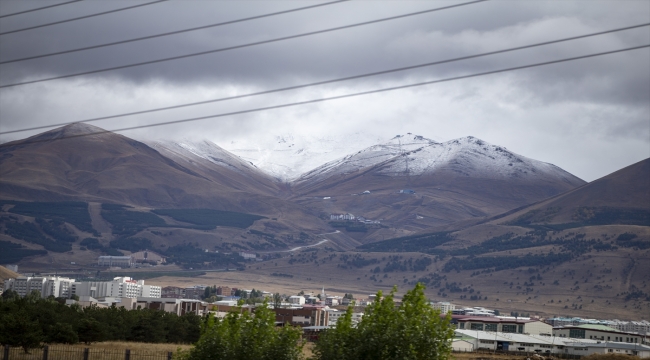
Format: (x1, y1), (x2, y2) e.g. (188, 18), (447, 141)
(2, 201), (100, 236)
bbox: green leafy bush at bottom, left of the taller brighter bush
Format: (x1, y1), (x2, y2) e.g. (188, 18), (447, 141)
(175, 302), (303, 360)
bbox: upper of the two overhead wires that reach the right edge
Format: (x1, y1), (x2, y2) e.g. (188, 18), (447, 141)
(0, 23), (650, 135)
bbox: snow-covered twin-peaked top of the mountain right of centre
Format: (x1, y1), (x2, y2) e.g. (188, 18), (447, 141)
(295, 133), (583, 186)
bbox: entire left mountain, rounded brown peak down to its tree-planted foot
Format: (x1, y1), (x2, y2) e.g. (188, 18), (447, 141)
(0, 124), (336, 268)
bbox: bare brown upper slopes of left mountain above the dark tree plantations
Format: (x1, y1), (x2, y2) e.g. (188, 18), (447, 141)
(0, 124), (275, 212)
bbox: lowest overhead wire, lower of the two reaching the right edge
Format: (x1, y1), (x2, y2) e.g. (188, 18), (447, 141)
(0, 44), (650, 148)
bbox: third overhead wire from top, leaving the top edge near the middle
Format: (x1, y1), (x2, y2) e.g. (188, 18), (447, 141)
(0, 0), (350, 65)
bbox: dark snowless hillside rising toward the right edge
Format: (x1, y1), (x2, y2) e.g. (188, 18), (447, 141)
(247, 159), (650, 320)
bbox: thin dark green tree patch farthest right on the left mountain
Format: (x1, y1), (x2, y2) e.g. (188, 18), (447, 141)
(153, 209), (266, 229)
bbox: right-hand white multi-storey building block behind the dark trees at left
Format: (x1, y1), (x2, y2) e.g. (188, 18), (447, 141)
(72, 277), (162, 298)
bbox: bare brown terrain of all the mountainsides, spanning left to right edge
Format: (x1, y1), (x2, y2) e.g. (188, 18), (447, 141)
(0, 124), (650, 319)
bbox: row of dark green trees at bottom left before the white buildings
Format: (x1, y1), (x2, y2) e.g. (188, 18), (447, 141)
(0, 290), (200, 350)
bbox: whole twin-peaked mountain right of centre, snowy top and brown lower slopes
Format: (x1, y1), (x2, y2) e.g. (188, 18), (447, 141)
(291, 134), (585, 239)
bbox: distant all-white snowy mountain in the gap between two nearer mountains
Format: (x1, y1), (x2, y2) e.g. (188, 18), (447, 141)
(223, 132), (388, 182)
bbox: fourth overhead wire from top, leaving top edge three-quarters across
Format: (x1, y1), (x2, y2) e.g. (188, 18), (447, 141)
(0, 0), (488, 88)
